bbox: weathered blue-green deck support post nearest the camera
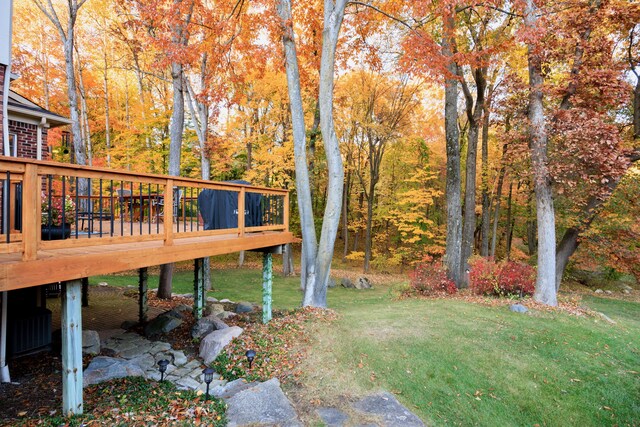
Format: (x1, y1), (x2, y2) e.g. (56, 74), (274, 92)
(61, 280), (83, 416)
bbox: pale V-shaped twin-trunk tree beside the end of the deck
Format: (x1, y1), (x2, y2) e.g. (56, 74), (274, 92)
(277, 0), (346, 307)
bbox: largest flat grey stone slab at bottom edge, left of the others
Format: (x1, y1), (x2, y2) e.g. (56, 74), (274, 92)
(227, 378), (302, 427)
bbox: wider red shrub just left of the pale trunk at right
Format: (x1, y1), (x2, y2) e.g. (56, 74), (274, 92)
(469, 258), (535, 297)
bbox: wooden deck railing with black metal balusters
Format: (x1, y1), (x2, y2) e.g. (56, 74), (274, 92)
(0, 157), (289, 260)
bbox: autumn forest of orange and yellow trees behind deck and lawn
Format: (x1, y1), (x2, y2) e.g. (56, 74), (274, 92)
(12, 0), (640, 302)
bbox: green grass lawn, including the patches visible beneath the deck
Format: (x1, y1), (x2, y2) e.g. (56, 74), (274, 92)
(92, 269), (640, 426)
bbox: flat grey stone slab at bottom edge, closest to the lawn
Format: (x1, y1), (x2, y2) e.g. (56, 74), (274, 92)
(353, 392), (425, 427)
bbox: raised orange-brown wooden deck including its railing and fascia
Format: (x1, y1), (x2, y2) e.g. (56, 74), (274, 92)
(0, 157), (294, 291)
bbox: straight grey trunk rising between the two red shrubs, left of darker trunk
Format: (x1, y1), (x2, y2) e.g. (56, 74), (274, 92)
(442, 10), (462, 286)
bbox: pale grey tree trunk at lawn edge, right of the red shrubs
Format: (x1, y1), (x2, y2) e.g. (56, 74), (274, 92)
(524, 0), (558, 306)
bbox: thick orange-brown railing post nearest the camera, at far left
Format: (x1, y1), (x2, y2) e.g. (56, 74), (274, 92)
(22, 164), (41, 261)
